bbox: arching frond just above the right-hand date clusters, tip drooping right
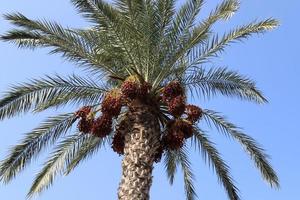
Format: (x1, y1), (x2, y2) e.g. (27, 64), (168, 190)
(183, 67), (268, 103)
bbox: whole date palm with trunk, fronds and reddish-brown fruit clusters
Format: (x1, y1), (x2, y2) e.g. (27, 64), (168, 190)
(0, 0), (279, 200)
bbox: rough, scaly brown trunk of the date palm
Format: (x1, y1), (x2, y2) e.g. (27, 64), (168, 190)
(118, 105), (160, 200)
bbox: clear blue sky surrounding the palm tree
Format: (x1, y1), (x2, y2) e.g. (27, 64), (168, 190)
(0, 0), (300, 200)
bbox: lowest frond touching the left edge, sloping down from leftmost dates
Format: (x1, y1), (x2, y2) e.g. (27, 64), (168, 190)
(0, 113), (76, 183)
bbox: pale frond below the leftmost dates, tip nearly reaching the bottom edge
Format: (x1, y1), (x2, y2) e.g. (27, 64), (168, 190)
(27, 134), (89, 199)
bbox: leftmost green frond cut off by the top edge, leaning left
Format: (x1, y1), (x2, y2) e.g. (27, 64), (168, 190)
(72, 0), (141, 75)
